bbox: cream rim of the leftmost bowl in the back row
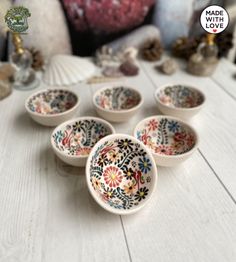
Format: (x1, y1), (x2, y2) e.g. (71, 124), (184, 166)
(25, 88), (80, 118)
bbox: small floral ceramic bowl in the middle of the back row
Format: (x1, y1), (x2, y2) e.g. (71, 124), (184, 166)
(93, 86), (143, 122)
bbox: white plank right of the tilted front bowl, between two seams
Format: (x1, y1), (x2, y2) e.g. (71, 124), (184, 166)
(123, 154), (236, 262)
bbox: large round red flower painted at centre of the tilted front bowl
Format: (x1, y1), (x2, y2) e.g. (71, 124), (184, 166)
(104, 166), (123, 187)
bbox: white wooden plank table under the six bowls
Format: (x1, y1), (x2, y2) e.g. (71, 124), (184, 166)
(0, 60), (236, 262)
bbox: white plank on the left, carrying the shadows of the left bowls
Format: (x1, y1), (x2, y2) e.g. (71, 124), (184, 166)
(0, 85), (129, 262)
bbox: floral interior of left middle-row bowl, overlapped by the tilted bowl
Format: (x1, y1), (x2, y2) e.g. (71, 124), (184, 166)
(52, 119), (113, 156)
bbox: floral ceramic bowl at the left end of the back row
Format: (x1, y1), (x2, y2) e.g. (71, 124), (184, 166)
(25, 89), (79, 126)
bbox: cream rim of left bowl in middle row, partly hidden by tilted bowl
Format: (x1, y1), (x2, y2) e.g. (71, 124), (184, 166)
(50, 116), (116, 159)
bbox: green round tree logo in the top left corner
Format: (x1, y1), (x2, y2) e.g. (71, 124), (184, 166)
(5, 6), (31, 33)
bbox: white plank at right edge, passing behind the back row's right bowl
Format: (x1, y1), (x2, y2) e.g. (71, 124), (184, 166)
(139, 59), (236, 199)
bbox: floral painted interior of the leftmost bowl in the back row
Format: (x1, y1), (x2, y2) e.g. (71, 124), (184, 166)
(27, 89), (78, 115)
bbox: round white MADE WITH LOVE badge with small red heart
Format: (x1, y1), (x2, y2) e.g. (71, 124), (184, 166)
(200, 5), (229, 34)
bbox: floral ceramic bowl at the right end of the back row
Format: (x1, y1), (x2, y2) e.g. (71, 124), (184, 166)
(155, 84), (205, 119)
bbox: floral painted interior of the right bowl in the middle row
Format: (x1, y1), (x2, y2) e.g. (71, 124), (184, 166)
(135, 117), (196, 156)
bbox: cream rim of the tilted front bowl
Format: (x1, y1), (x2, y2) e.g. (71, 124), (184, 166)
(85, 133), (158, 215)
